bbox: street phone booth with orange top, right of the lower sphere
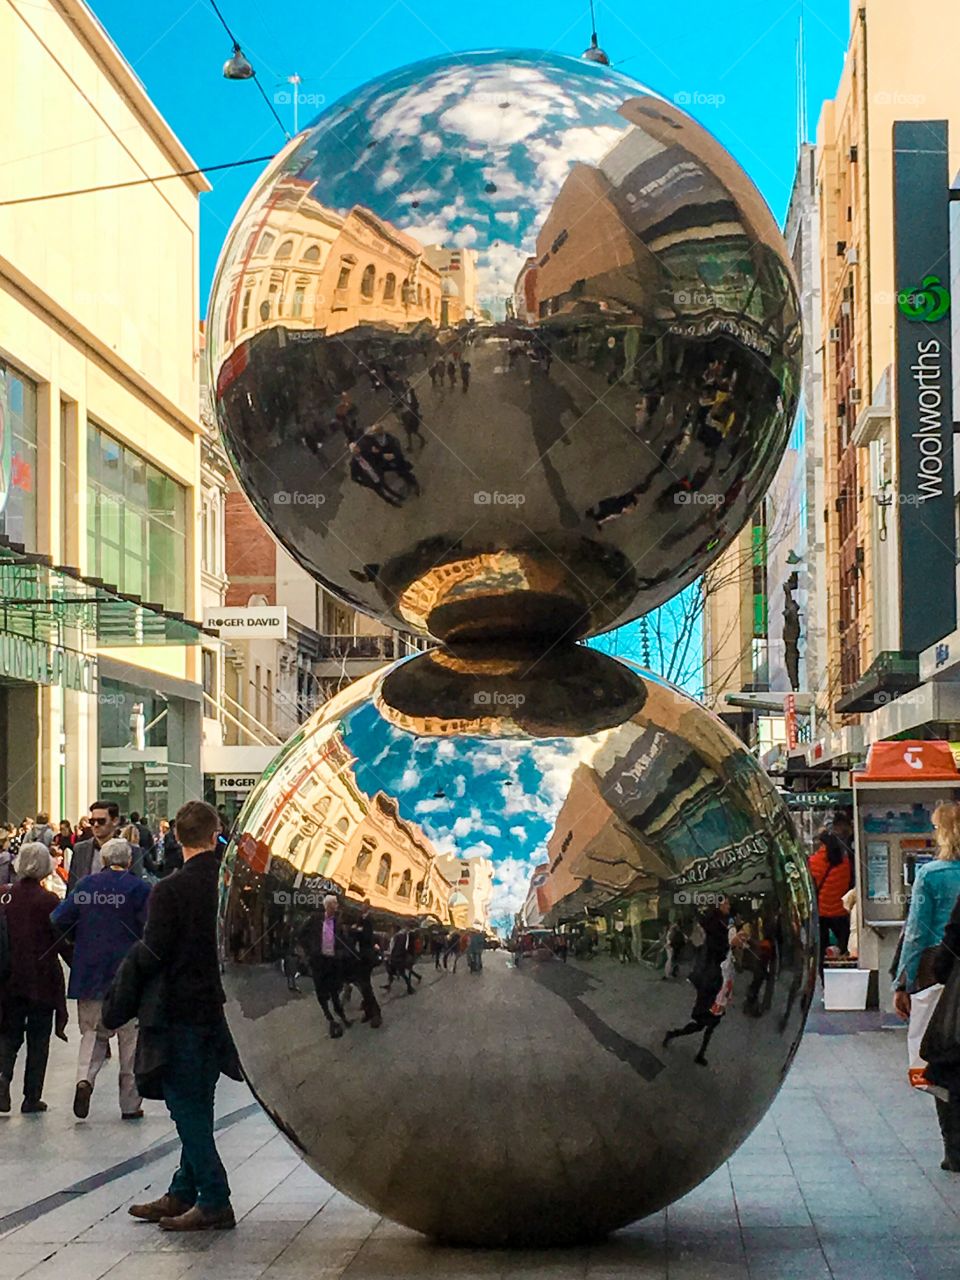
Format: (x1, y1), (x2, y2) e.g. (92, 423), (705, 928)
(852, 741), (960, 1010)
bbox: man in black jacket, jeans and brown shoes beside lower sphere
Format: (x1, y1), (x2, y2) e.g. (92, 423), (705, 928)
(129, 800), (236, 1231)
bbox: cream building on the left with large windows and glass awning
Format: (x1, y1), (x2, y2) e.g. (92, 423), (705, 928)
(0, 0), (209, 820)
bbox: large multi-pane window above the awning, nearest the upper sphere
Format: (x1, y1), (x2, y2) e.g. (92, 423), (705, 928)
(87, 422), (187, 612)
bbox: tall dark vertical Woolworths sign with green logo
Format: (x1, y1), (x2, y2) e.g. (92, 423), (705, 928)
(893, 120), (956, 653)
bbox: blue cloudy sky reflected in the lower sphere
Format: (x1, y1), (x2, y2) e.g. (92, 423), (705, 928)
(340, 703), (582, 928)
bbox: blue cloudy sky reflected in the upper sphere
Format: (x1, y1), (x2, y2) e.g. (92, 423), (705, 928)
(288, 52), (649, 317)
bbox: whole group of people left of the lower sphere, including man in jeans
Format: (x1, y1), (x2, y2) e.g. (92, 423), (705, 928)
(0, 800), (241, 1231)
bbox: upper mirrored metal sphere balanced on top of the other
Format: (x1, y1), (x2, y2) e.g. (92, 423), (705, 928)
(207, 52), (800, 641)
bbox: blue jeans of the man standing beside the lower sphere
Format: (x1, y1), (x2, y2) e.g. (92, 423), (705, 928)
(164, 1024), (230, 1210)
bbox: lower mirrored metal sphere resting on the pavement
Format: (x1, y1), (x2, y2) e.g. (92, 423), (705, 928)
(221, 646), (814, 1244)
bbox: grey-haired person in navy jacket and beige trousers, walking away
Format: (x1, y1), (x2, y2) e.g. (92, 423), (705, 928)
(51, 840), (150, 1120)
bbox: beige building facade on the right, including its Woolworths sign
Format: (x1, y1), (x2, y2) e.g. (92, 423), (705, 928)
(805, 0), (960, 768)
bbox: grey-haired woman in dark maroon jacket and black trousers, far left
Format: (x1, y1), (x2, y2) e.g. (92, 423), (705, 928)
(0, 841), (67, 1112)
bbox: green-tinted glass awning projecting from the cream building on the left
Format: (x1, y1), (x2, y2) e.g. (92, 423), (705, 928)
(0, 536), (212, 649)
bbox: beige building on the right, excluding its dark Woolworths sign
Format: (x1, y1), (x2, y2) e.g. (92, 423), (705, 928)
(814, 0), (960, 763)
